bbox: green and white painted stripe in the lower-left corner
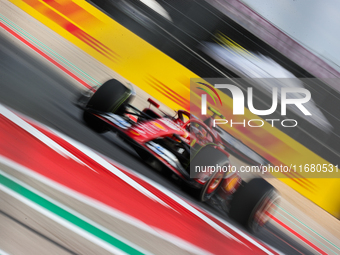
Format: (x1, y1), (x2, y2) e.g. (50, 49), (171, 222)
(0, 170), (147, 254)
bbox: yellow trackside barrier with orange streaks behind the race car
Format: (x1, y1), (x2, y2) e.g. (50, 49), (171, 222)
(1, 0), (339, 215)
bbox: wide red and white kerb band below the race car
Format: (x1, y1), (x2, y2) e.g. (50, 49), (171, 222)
(0, 104), (275, 254)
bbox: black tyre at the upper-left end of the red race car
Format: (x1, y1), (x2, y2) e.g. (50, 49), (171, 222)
(83, 79), (131, 133)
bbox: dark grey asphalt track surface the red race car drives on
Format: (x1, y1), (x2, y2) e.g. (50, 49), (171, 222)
(0, 21), (322, 254)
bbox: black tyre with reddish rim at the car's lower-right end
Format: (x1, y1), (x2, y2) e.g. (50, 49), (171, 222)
(229, 178), (279, 231)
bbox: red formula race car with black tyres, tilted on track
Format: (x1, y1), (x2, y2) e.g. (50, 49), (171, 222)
(78, 79), (278, 230)
